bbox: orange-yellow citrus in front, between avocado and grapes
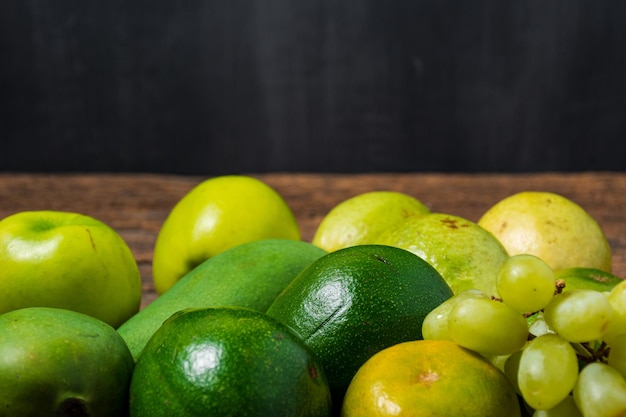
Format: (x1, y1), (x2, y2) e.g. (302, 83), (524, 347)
(341, 340), (521, 417)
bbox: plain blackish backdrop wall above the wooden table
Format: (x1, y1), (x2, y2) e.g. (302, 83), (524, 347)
(0, 0), (626, 175)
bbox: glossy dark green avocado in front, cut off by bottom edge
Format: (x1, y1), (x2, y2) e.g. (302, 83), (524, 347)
(130, 307), (331, 417)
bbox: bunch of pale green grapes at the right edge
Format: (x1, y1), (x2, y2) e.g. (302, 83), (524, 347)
(422, 255), (626, 417)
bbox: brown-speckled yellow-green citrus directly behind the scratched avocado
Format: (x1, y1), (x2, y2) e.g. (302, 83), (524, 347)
(377, 213), (509, 296)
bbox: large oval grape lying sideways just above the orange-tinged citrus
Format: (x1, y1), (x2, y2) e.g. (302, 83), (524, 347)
(448, 298), (528, 355)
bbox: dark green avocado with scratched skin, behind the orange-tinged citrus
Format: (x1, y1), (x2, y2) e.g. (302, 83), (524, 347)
(267, 245), (452, 401)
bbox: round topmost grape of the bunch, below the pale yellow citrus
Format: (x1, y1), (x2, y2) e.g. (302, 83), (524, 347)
(496, 254), (555, 313)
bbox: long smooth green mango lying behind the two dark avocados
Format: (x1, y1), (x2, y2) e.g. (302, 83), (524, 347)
(118, 239), (326, 360)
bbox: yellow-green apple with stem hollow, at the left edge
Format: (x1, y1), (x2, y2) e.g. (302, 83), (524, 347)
(0, 211), (142, 327)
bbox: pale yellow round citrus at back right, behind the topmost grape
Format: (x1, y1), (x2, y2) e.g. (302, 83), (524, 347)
(478, 191), (611, 272)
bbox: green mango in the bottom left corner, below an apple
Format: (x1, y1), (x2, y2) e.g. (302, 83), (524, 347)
(0, 307), (134, 417)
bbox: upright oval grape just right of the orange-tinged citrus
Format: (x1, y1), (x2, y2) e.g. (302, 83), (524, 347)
(517, 333), (578, 410)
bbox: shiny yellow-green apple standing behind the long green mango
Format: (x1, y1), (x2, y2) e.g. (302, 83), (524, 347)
(152, 175), (300, 294)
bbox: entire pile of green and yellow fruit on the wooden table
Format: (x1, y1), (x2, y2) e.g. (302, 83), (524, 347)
(0, 176), (626, 417)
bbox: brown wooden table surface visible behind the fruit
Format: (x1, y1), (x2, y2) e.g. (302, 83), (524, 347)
(0, 172), (626, 306)
